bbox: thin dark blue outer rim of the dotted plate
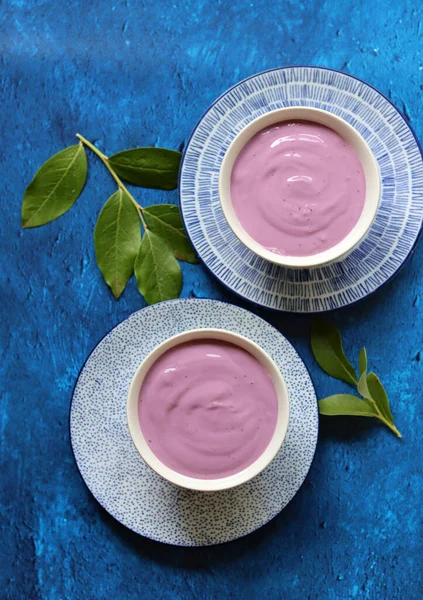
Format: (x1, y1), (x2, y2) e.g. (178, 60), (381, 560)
(68, 298), (320, 548)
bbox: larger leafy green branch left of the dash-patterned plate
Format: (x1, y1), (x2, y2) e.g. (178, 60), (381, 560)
(22, 133), (197, 304)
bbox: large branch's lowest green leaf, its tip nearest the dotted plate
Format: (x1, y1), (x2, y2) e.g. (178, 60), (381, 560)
(135, 229), (182, 304)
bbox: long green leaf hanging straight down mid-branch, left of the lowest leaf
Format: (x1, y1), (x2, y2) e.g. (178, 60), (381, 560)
(94, 190), (141, 298)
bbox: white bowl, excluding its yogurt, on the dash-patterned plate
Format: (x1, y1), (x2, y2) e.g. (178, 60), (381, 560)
(219, 106), (381, 268)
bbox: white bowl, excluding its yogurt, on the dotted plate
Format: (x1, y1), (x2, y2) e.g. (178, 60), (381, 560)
(127, 329), (289, 492)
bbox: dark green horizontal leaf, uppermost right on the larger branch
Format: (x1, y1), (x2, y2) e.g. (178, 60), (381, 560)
(109, 148), (182, 190)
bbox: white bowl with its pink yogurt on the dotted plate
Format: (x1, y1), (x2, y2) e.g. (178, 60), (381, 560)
(127, 329), (289, 491)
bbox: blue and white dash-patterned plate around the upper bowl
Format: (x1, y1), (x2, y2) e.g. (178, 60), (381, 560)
(179, 67), (423, 313)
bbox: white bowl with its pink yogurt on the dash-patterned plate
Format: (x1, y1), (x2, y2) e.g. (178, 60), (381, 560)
(219, 107), (381, 268)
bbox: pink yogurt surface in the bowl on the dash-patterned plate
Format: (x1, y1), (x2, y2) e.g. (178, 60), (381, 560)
(231, 121), (366, 256)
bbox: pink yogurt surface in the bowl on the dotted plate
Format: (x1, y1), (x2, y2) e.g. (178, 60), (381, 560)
(138, 339), (278, 479)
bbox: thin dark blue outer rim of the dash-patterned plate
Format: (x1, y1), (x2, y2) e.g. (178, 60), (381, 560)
(178, 65), (423, 316)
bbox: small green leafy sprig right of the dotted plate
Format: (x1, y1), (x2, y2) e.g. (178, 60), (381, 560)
(311, 319), (402, 437)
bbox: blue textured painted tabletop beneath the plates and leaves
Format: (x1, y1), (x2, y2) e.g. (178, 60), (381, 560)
(0, 0), (423, 600)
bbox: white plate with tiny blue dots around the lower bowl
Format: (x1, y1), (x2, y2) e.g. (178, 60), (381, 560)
(70, 299), (318, 546)
